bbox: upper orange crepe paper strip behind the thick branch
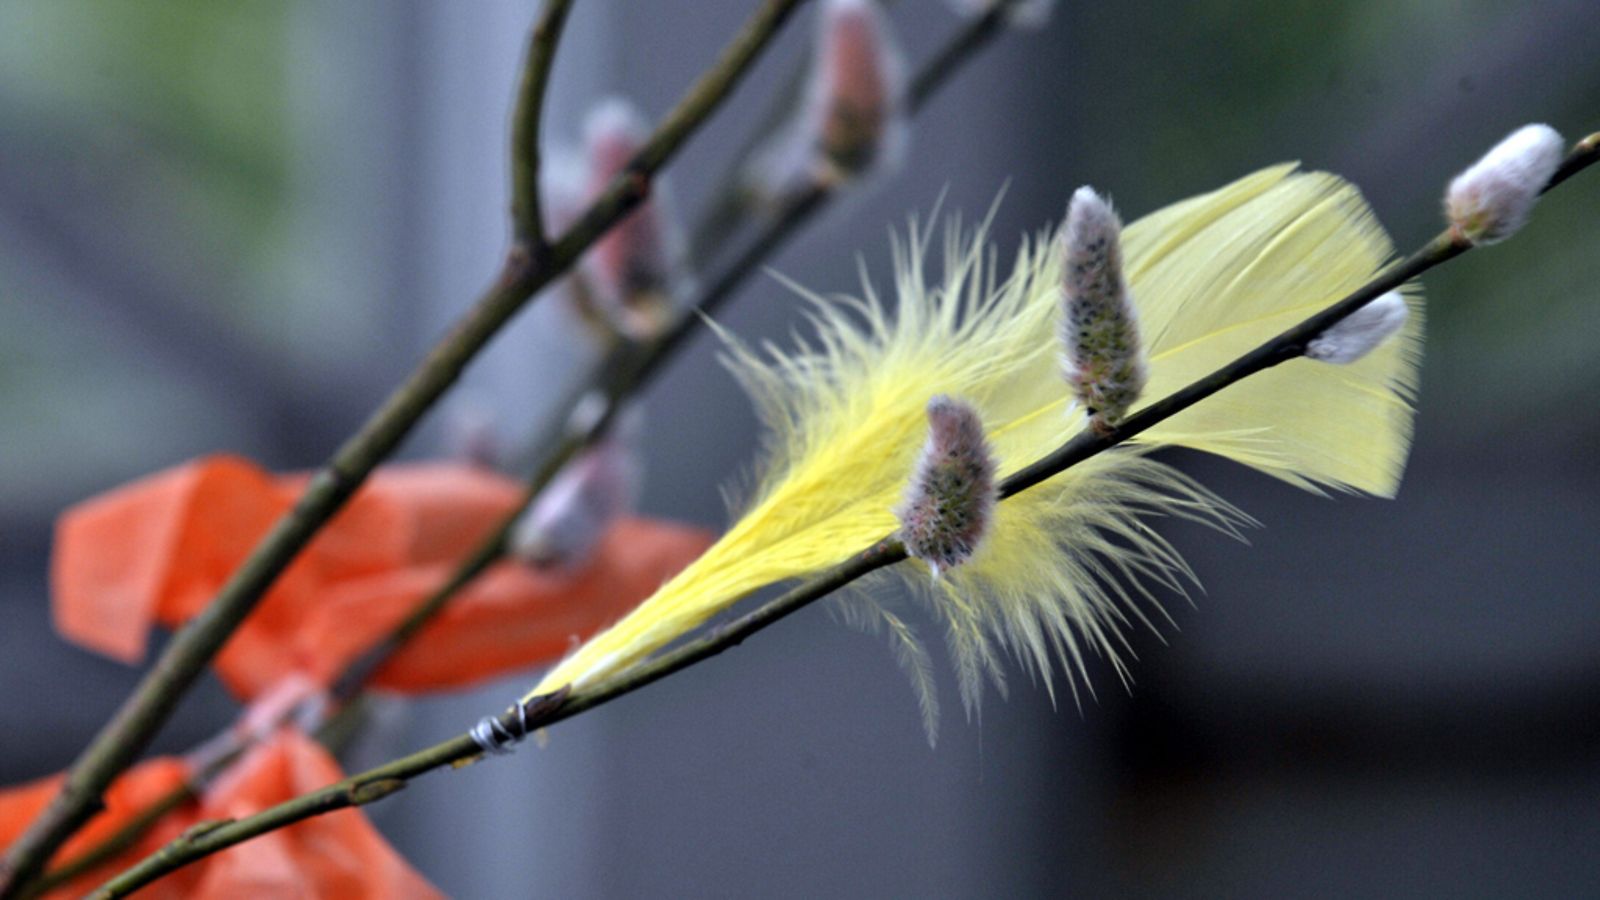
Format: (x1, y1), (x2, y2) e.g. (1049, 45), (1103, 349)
(51, 456), (710, 700)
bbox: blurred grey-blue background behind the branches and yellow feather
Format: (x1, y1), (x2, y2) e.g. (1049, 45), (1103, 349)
(0, 0), (1600, 897)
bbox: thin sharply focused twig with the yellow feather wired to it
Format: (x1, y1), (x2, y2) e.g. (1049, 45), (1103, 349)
(94, 135), (1600, 898)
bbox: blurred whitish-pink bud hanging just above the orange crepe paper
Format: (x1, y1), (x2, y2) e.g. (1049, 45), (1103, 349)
(510, 439), (640, 569)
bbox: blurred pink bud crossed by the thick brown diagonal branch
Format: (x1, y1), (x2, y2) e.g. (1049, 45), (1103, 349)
(582, 99), (682, 340)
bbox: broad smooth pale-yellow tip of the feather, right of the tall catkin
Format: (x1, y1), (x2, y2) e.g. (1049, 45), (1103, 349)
(1123, 165), (1422, 496)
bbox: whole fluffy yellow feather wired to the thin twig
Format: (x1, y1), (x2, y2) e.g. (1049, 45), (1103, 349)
(533, 165), (1421, 733)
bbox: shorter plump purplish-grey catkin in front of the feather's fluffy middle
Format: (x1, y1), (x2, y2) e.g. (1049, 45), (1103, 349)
(894, 394), (997, 578)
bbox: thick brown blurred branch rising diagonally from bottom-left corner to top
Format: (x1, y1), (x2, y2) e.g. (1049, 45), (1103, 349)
(0, 0), (803, 898)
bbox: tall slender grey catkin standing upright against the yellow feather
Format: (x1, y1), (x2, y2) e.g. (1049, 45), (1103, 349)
(1061, 187), (1147, 426)
